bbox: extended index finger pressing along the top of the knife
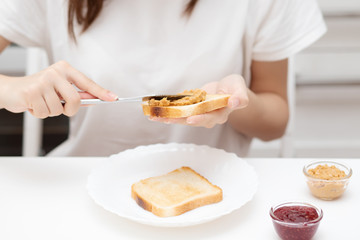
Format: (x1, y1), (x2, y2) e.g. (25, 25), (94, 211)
(55, 62), (118, 101)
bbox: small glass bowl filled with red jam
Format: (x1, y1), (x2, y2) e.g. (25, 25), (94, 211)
(270, 202), (323, 240)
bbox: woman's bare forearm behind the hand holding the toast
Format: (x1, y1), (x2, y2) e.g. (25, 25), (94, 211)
(229, 90), (289, 141)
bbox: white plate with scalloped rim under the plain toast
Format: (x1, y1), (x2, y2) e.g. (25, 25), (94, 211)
(87, 143), (257, 227)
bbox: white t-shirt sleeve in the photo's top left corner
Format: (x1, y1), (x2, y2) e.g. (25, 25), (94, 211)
(0, 0), (47, 47)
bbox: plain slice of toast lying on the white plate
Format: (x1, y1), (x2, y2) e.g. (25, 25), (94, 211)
(131, 167), (223, 217)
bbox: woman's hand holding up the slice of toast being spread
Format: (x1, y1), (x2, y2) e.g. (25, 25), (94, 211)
(150, 75), (249, 128)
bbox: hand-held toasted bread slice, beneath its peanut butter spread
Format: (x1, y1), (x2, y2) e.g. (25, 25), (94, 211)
(142, 94), (230, 118)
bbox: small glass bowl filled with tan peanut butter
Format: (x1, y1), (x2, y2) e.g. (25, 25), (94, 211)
(303, 161), (352, 200)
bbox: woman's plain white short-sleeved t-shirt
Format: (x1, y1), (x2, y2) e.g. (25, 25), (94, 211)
(0, 0), (326, 156)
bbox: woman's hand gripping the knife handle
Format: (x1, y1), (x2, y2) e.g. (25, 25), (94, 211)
(0, 61), (117, 118)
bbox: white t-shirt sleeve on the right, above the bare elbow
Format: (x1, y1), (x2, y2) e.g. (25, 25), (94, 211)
(252, 0), (326, 61)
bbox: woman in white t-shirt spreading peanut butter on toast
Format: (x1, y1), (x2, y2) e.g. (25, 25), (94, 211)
(0, 0), (325, 156)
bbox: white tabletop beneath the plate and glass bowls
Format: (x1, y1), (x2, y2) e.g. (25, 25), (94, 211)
(0, 157), (360, 240)
